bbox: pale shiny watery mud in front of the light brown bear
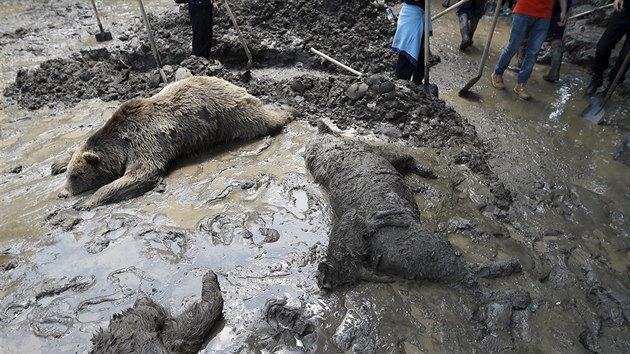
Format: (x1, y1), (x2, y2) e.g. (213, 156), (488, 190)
(0, 111), (330, 352)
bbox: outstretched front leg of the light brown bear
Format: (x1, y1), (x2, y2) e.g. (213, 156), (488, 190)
(76, 171), (161, 209)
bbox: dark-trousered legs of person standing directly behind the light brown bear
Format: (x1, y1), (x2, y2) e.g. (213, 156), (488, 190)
(188, 0), (212, 59)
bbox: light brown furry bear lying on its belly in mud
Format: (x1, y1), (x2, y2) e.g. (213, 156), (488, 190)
(51, 76), (292, 209)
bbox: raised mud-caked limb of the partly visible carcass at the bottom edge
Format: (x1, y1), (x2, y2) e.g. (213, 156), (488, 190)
(161, 271), (223, 353)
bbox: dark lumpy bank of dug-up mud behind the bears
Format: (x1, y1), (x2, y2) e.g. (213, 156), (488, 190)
(4, 0), (498, 184)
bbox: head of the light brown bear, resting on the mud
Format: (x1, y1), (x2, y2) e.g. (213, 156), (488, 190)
(66, 146), (120, 195)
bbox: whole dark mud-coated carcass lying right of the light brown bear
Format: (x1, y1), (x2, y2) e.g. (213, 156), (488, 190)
(305, 122), (529, 292)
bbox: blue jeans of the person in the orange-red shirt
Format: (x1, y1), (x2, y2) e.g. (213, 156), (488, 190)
(494, 14), (549, 84)
